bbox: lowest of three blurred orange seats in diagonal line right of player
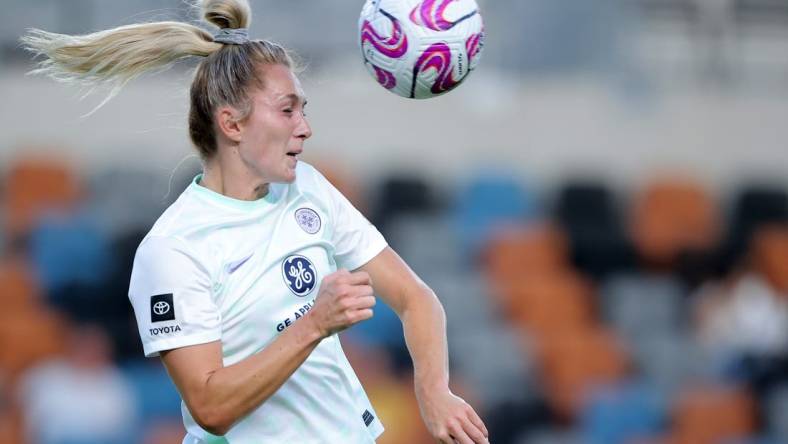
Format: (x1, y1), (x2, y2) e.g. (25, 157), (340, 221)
(536, 327), (629, 419)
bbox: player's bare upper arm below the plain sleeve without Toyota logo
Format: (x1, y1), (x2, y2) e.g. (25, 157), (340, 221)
(359, 247), (432, 316)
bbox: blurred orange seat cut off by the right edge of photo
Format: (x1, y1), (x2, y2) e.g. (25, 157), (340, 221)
(751, 225), (788, 295)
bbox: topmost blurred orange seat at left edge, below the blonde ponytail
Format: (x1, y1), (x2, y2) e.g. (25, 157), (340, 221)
(3, 158), (82, 237)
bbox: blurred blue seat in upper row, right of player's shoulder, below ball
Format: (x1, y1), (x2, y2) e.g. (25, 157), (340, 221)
(453, 174), (540, 258)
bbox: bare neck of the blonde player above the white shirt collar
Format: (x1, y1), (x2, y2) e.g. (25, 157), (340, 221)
(200, 149), (269, 200)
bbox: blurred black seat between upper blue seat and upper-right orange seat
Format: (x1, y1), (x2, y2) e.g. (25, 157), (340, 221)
(553, 180), (634, 278)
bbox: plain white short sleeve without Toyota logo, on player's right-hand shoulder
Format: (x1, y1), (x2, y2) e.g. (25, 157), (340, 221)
(317, 173), (388, 270)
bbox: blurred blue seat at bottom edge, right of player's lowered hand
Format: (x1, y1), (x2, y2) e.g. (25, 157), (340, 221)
(579, 380), (667, 444)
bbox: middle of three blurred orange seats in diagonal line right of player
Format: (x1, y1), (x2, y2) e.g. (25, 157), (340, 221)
(494, 271), (596, 335)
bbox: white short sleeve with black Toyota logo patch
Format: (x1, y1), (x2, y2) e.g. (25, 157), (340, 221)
(129, 236), (221, 357)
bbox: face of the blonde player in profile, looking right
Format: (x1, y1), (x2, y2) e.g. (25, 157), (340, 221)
(238, 65), (312, 183)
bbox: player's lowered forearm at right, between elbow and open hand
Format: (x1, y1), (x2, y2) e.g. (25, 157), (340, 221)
(400, 286), (449, 390)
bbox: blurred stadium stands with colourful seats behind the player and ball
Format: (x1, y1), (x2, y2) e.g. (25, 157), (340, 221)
(0, 0), (788, 444)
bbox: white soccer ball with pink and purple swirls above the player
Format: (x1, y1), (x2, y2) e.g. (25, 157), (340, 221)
(358, 0), (484, 99)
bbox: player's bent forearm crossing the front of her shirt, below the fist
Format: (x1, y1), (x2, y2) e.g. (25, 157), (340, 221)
(195, 315), (322, 435)
